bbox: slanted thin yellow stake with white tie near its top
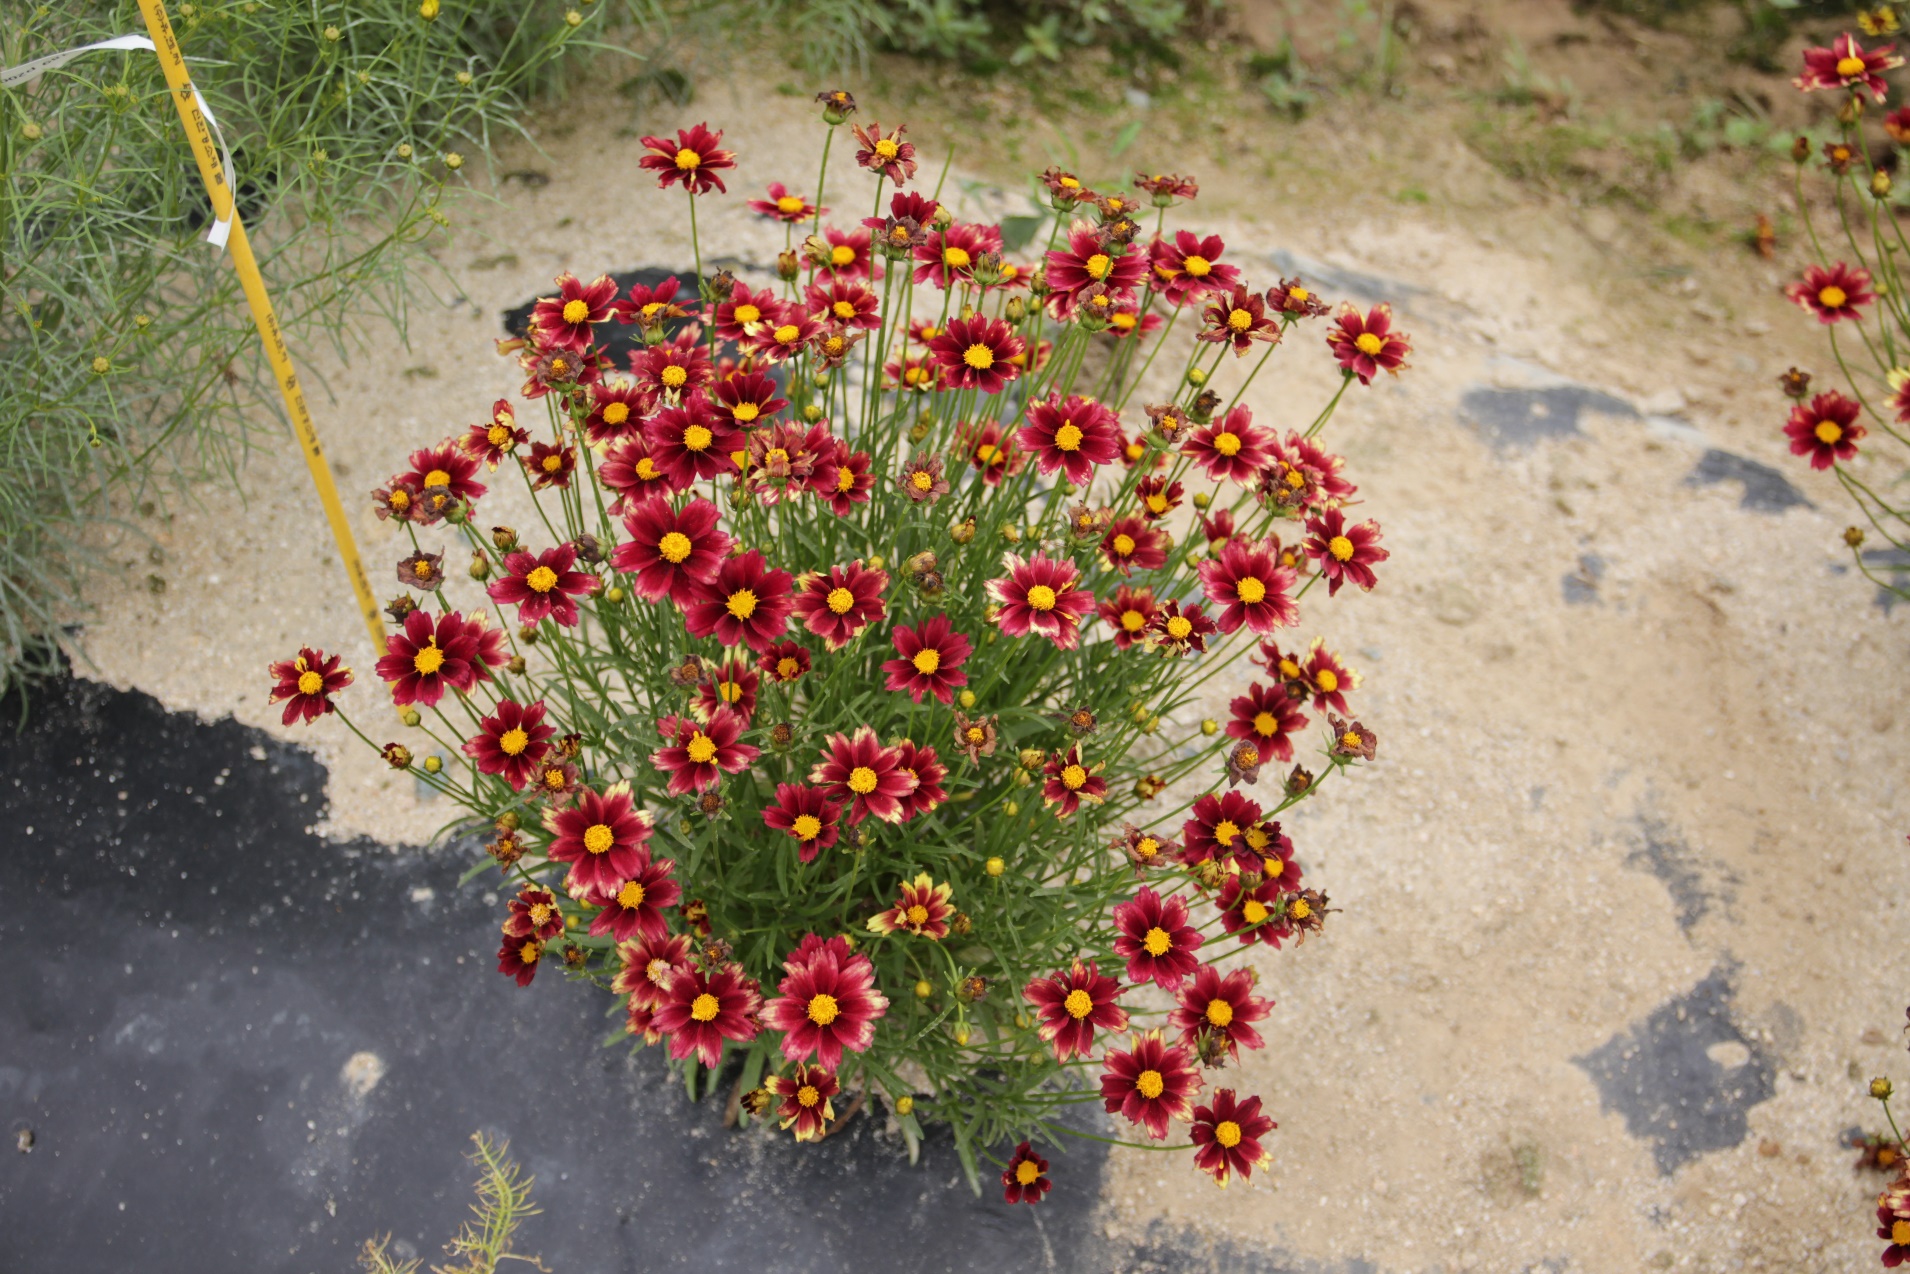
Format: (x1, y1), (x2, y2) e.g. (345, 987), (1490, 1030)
(139, 0), (384, 655)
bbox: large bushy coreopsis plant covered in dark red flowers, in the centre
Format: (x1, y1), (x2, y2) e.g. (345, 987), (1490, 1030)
(273, 94), (1410, 1203)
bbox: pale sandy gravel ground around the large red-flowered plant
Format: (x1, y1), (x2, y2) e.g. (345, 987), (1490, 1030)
(59, 67), (1910, 1272)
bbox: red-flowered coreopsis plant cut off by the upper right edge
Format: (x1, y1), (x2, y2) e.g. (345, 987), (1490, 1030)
(1780, 34), (1910, 600)
